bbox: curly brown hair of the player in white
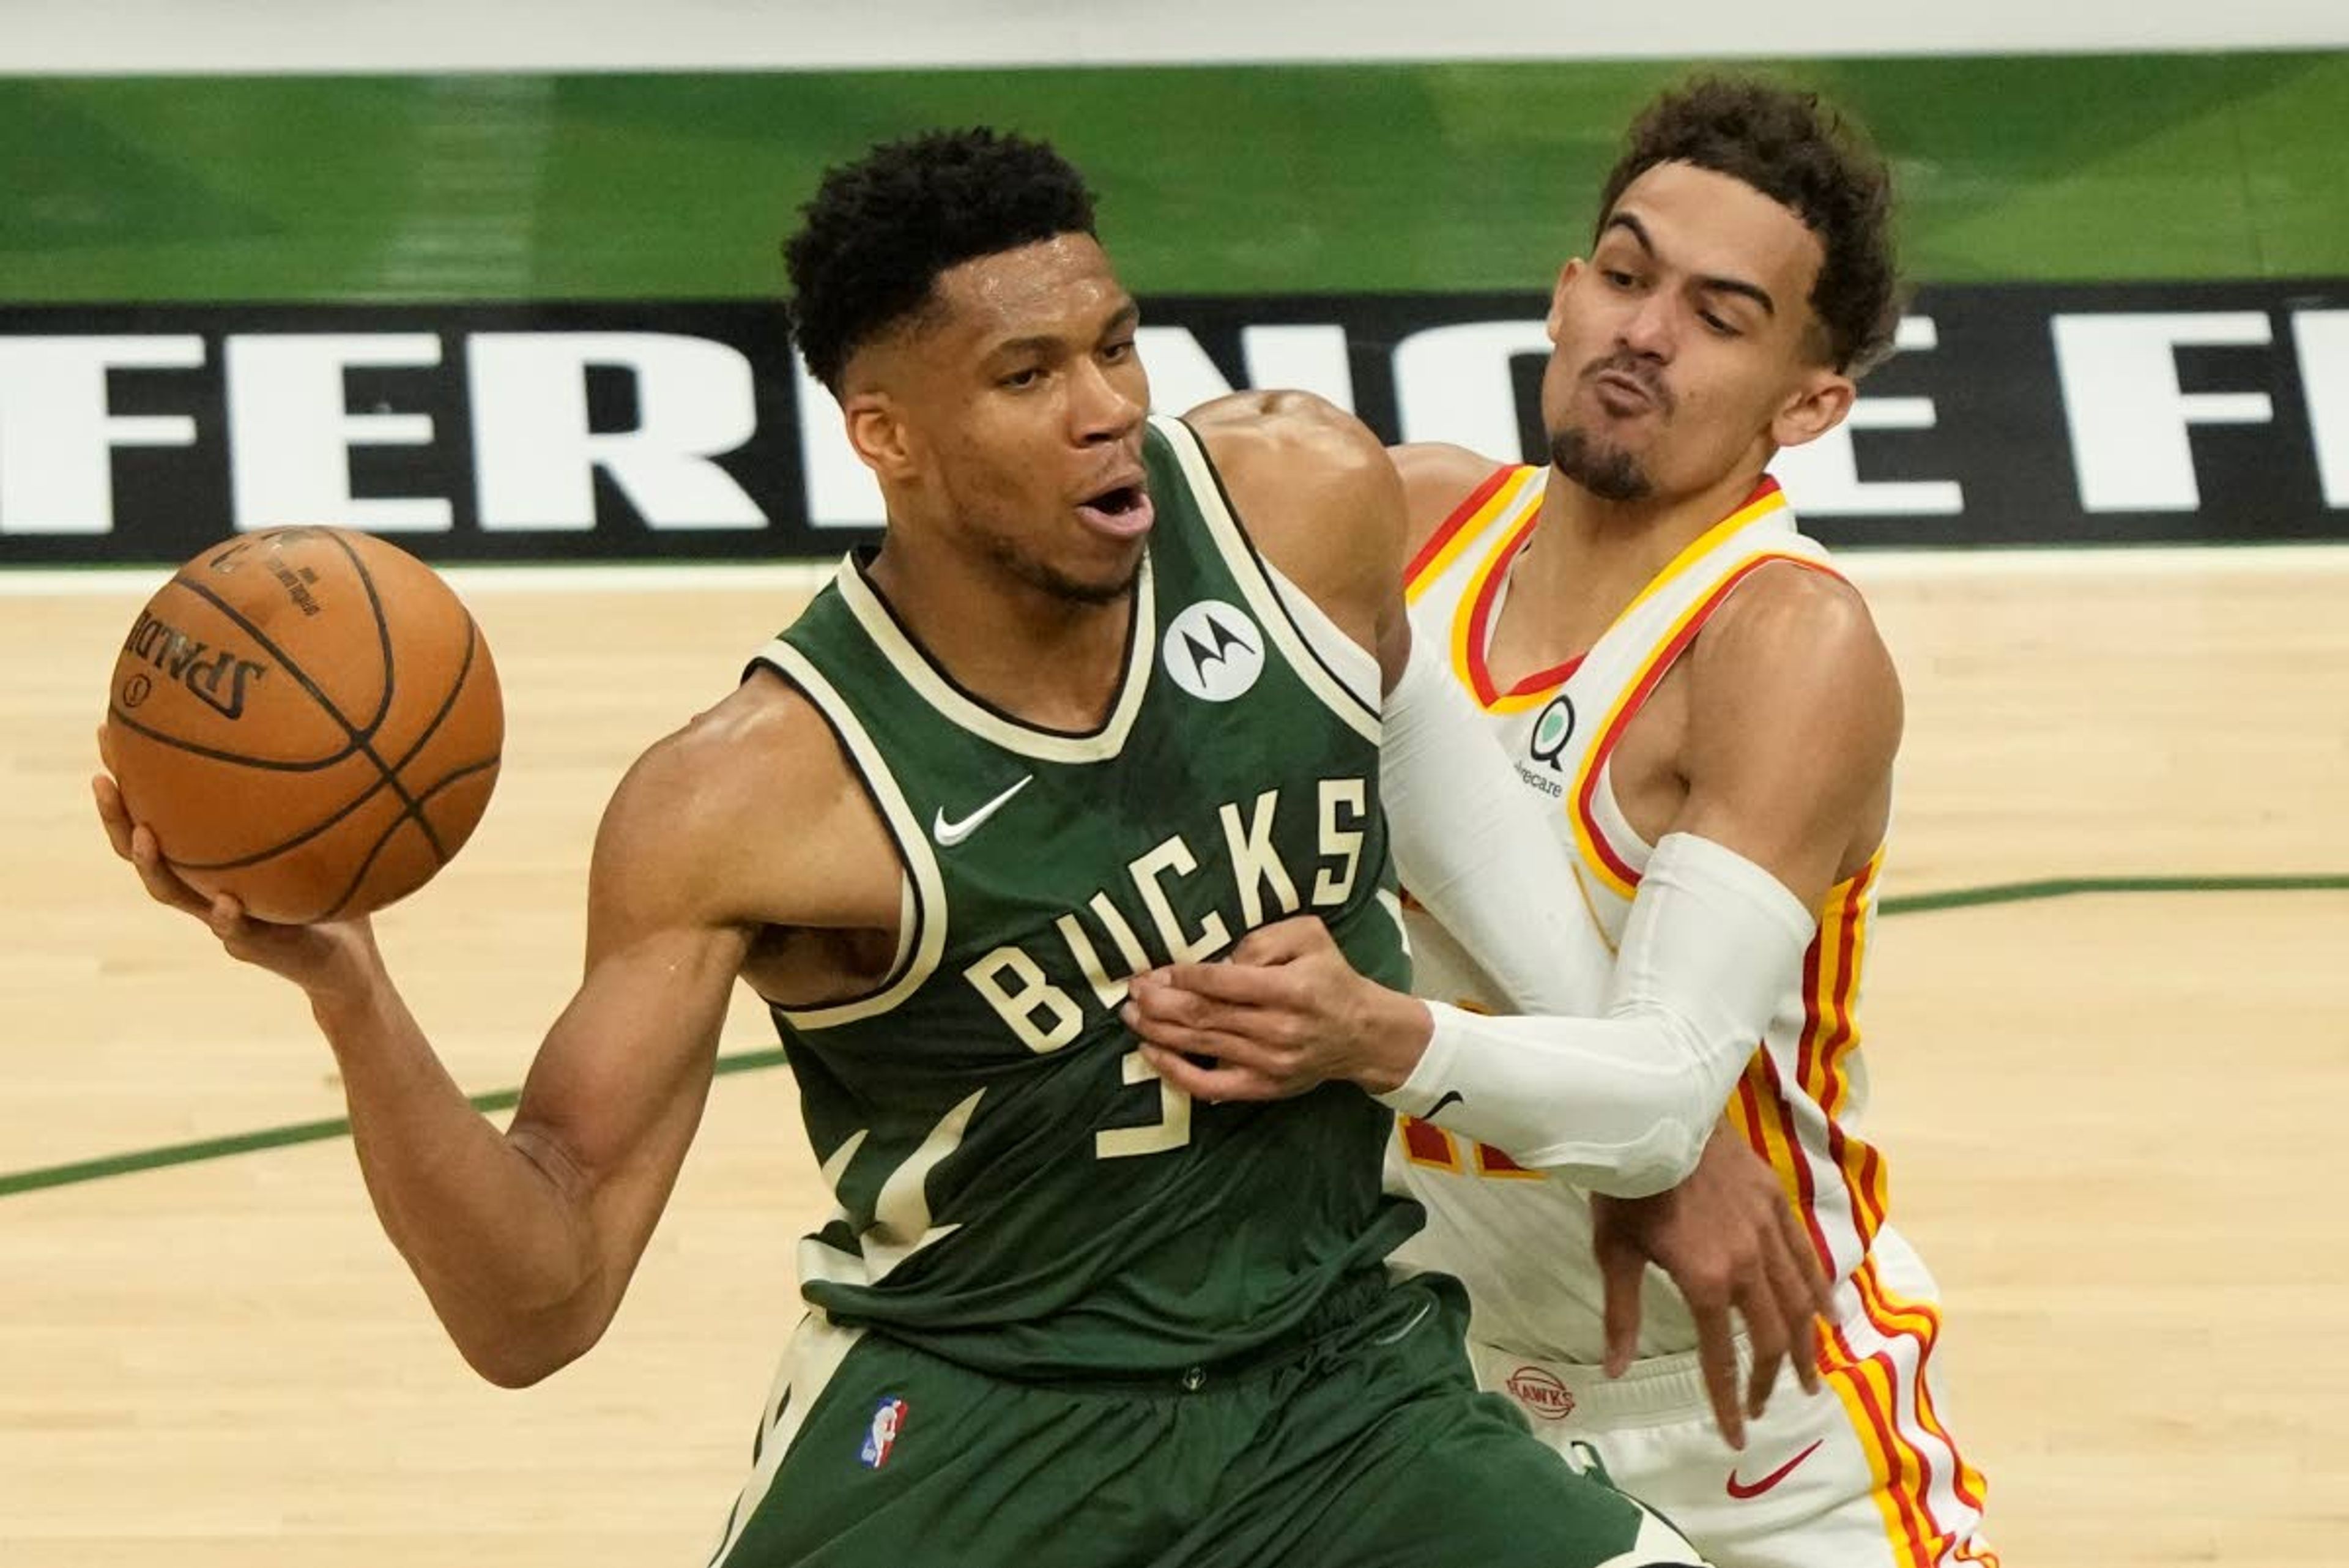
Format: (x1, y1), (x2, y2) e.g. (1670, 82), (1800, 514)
(1600, 78), (1901, 376)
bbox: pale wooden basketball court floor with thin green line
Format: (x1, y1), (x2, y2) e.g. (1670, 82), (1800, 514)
(0, 550), (2349, 1568)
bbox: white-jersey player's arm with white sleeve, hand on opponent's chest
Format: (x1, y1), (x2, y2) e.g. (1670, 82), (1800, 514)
(1130, 567), (1901, 1197)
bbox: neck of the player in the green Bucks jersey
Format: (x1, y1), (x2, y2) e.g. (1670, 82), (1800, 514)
(864, 536), (1135, 731)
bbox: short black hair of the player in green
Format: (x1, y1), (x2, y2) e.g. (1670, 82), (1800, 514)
(782, 125), (1093, 395)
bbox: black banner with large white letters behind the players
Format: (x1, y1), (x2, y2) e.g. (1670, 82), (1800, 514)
(0, 280), (2349, 564)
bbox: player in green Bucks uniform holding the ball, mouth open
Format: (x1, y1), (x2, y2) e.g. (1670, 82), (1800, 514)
(98, 132), (1698, 1568)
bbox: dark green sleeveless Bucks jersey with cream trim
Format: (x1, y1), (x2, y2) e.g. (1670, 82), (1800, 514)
(759, 418), (1419, 1375)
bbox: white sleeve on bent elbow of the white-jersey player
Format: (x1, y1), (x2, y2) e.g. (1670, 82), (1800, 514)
(1379, 832), (1818, 1197)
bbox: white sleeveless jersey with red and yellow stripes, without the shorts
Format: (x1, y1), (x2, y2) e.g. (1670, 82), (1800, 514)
(1390, 468), (1887, 1364)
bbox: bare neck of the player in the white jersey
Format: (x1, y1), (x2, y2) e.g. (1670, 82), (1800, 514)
(1510, 453), (1762, 625)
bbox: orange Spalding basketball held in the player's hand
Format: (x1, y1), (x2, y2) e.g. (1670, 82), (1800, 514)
(103, 529), (505, 924)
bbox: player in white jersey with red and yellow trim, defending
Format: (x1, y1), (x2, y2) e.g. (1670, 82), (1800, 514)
(1135, 82), (1997, 1568)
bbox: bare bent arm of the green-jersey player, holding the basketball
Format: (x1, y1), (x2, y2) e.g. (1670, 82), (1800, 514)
(98, 694), (874, 1387)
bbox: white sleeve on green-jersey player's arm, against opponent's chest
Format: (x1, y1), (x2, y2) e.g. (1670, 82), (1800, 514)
(1379, 637), (1611, 1013)
